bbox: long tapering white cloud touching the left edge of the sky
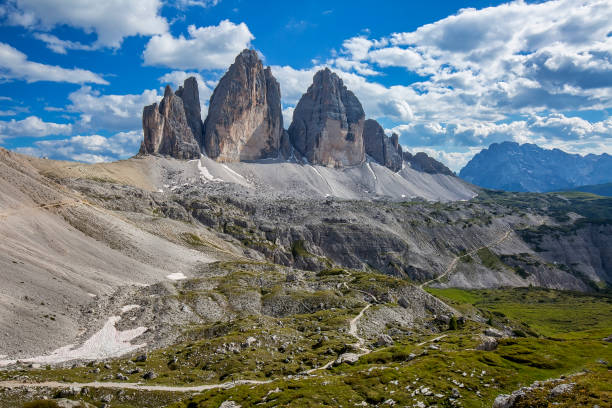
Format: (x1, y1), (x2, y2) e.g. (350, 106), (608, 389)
(0, 42), (108, 85)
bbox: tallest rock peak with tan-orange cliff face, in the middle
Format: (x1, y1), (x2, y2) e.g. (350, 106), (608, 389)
(204, 50), (283, 162)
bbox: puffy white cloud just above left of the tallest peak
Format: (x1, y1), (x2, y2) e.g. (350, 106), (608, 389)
(143, 20), (255, 70)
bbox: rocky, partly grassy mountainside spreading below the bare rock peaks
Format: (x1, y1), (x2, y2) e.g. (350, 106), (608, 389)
(0, 151), (612, 407)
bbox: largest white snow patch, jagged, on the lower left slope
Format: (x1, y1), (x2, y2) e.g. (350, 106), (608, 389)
(0, 316), (147, 367)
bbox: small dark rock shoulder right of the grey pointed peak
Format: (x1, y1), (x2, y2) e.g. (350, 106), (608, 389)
(363, 119), (404, 171)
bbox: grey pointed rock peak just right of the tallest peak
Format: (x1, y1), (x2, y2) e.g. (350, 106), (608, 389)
(289, 68), (365, 167)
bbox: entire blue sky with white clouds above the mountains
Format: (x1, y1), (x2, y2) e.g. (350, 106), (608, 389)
(0, 0), (612, 170)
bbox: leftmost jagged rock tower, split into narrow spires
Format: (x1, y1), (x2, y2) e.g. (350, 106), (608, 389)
(140, 81), (200, 159)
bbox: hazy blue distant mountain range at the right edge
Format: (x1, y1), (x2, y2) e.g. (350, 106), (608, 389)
(459, 142), (612, 192)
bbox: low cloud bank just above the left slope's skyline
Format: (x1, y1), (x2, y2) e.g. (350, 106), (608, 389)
(16, 131), (142, 163)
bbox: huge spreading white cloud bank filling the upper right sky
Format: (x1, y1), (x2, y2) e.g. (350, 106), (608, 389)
(328, 0), (612, 123)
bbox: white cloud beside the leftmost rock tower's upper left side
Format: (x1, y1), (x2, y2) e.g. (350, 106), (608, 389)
(67, 86), (161, 131)
